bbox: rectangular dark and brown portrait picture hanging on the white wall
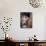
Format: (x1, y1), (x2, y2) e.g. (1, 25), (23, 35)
(20, 12), (32, 28)
